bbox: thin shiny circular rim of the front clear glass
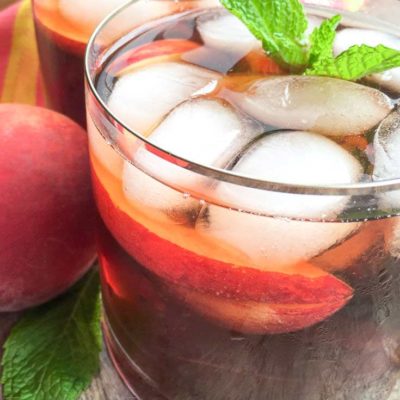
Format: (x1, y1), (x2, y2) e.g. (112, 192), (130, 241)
(84, 0), (400, 196)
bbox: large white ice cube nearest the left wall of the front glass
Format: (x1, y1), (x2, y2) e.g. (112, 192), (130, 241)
(108, 62), (220, 135)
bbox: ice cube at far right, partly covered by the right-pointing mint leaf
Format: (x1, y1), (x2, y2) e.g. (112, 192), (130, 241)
(334, 28), (400, 93)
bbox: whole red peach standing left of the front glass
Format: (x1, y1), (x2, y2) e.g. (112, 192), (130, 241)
(0, 104), (96, 311)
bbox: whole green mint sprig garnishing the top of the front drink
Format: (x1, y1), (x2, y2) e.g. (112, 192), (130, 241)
(221, 0), (400, 80)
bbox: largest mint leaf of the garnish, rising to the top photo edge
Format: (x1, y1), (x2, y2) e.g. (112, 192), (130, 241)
(221, 0), (308, 70)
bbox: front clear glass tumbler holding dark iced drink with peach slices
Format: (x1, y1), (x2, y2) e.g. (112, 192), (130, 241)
(86, 0), (400, 400)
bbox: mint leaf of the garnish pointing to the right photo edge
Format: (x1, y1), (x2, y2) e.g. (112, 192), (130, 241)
(305, 45), (400, 81)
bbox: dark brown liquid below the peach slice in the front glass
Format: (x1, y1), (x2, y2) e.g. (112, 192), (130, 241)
(99, 219), (400, 400)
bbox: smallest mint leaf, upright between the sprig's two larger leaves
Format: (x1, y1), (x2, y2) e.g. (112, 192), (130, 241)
(309, 15), (342, 65)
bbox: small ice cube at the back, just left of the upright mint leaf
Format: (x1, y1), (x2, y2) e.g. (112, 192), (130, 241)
(197, 12), (261, 56)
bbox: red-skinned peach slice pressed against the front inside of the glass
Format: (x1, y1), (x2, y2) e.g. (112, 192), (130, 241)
(93, 172), (353, 333)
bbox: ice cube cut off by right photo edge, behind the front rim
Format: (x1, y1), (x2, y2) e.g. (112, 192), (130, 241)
(373, 110), (400, 210)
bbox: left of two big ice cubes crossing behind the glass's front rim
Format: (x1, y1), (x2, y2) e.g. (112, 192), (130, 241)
(123, 98), (262, 220)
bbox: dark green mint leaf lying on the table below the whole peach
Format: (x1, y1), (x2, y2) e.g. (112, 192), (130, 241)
(1, 271), (102, 400)
